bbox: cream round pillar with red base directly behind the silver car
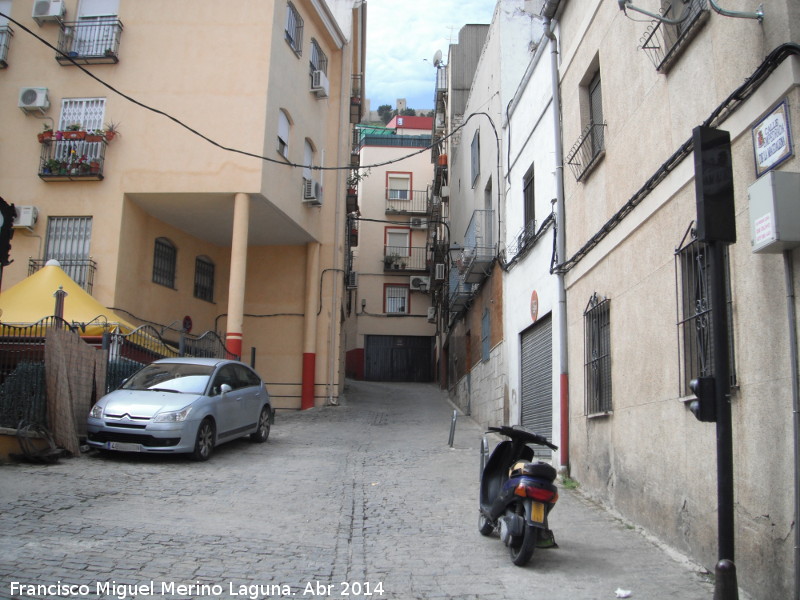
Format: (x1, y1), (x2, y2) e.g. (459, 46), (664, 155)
(225, 193), (250, 356)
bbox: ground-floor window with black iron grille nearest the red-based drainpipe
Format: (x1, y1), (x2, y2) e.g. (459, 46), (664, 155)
(583, 294), (612, 415)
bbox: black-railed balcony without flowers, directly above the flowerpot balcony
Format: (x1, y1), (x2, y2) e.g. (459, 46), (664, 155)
(56, 18), (122, 65)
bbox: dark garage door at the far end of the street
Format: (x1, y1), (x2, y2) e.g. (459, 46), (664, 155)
(364, 335), (433, 382)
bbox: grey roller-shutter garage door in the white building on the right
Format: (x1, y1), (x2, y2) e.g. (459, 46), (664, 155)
(520, 315), (553, 456)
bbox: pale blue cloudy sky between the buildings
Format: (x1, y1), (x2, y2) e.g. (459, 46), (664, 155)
(366, 0), (495, 110)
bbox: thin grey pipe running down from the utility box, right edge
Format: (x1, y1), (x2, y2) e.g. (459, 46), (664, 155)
(783, 250), (800, 600)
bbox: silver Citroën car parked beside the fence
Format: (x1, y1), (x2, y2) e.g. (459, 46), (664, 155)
(87, 358), (273, 460)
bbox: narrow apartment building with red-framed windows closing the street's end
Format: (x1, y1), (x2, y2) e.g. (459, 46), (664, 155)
(345, 116), (434, 381)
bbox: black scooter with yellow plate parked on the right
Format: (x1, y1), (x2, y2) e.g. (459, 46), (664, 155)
(478, 426), (558, 567)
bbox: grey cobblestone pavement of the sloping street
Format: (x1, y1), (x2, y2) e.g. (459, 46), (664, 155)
(0, 382), (713, 600)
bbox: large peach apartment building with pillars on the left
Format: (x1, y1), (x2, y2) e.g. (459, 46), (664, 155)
(0, 0), (366, 408)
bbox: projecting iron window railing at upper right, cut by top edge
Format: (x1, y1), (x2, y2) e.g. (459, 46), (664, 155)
(641, 0), (709, 73)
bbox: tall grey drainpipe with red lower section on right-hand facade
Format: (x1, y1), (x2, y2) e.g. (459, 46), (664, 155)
(542, 0), (569, 473)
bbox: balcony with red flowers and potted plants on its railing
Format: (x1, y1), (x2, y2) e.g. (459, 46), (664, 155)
(39, 137), (106, 181)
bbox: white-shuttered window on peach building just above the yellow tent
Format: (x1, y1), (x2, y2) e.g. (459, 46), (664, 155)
(44, 217), (93, 289)
